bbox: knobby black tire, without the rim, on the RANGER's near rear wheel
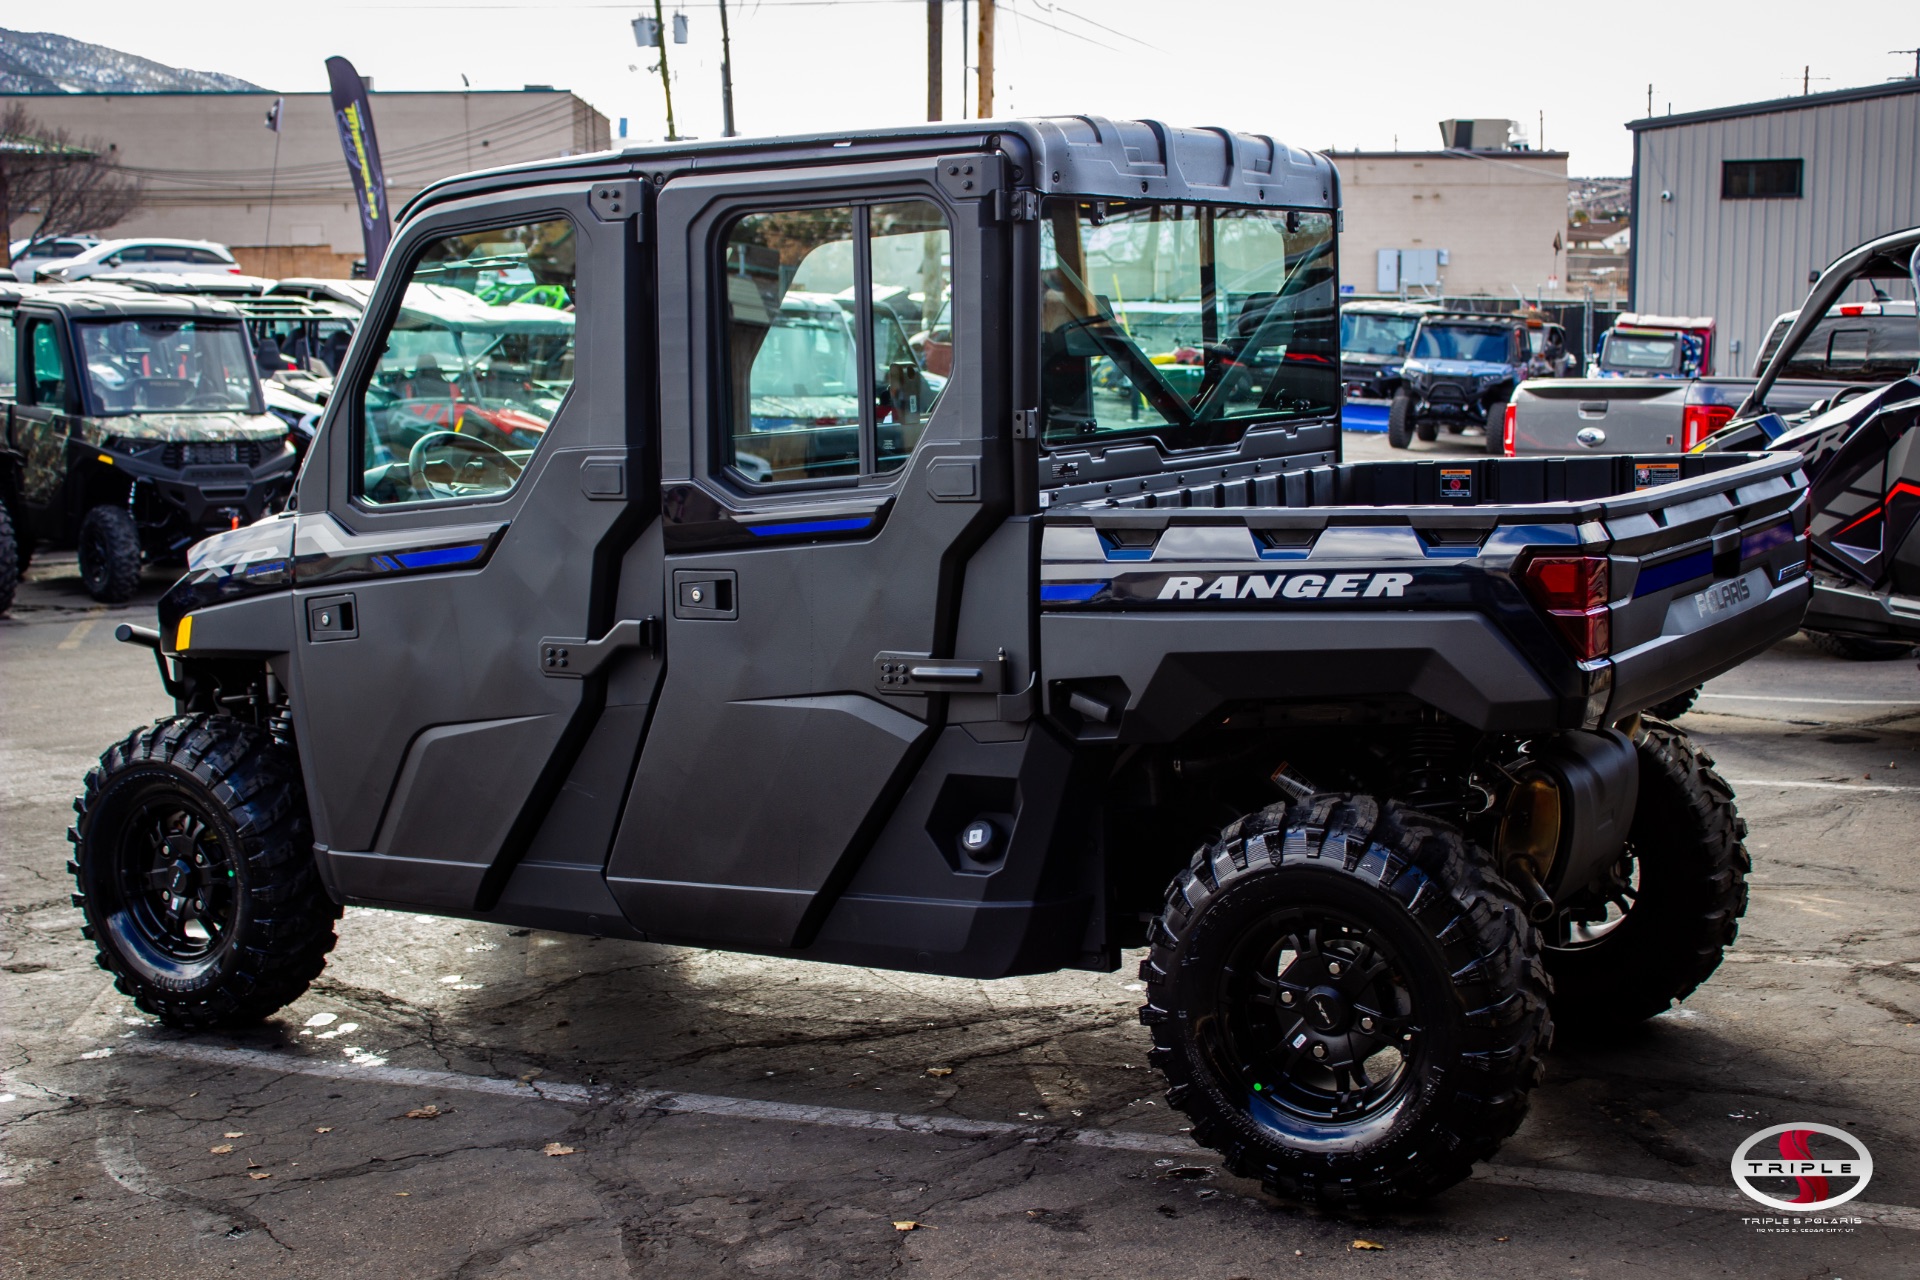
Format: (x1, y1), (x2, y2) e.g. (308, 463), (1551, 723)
(1140, 794), (1551, 1205)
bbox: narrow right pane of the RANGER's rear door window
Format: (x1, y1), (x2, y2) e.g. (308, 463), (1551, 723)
(868, 200), (952, 472)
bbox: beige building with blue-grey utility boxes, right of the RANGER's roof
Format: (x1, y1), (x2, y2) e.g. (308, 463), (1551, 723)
(1329, 150), (1567, 299)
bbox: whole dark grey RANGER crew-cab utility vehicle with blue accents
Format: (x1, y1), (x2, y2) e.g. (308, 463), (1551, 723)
(73, 117), (1807, 1201)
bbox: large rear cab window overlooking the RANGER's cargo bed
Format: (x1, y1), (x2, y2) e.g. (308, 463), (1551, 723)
(1041, 200), (1340, 449)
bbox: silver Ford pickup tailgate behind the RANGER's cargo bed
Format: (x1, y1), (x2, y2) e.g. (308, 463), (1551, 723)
(1513, 378), (1688, 457)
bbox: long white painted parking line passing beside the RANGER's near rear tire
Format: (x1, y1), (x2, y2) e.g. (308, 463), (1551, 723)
(119, 1040), (1920, 1230)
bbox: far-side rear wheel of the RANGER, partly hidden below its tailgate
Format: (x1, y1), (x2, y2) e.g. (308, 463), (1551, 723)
(1546, 720), (1753, 1032)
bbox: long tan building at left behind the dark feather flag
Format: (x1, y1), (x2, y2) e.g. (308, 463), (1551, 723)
(0, 88), (611, 276)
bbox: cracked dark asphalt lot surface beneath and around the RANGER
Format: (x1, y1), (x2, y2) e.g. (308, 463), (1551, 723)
(0, 521), (1920, 1280)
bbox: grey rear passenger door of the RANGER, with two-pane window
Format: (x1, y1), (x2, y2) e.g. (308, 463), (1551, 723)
(609, 157), (1023, 948)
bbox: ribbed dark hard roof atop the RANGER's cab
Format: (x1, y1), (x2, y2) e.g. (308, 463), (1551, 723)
(399, 115), (1340, 223)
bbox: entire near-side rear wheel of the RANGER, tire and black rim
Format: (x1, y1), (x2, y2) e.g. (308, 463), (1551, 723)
(1140, 794), (1551, 1205)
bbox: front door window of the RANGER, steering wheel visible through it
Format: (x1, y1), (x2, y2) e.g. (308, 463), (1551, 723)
(357, 219), (578, 503)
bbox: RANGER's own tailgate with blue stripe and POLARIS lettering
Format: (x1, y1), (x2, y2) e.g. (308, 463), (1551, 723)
(1603, 453), (1811, 720)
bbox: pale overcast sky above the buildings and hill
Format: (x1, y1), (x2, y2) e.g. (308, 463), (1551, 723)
(15, 0), (1920, 175)
